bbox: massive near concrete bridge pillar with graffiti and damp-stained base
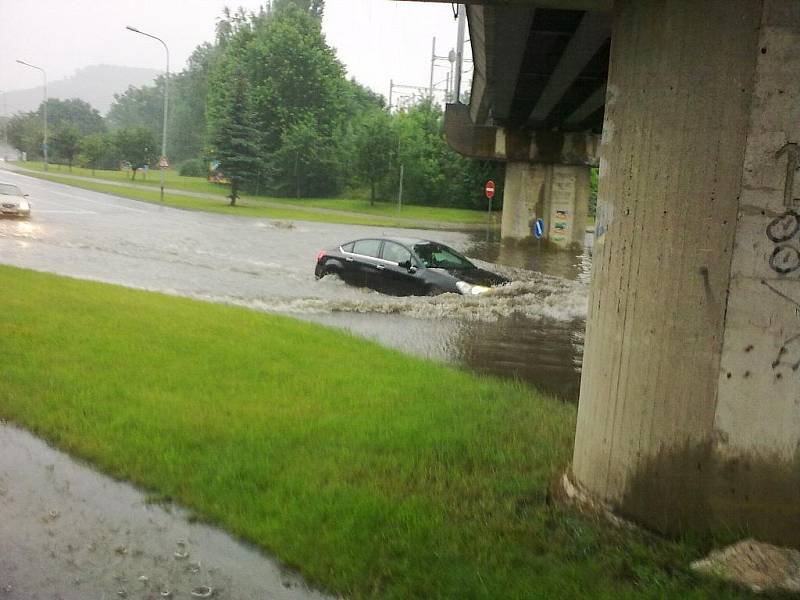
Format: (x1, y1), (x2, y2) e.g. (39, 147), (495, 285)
(572, 0), (800, 545)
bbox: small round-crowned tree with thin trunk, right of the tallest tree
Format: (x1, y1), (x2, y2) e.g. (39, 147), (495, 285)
(353, 110), (397, 204)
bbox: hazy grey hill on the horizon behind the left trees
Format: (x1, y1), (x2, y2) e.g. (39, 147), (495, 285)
(0, 65), (161, 115)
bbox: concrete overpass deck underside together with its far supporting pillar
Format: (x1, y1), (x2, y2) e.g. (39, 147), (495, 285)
(422, 1), (611, 246)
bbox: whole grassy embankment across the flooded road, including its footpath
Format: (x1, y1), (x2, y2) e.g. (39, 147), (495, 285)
(16, 161), (490, 227)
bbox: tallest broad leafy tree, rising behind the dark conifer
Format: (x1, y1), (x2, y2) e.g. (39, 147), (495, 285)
(208, 0), (348, 196)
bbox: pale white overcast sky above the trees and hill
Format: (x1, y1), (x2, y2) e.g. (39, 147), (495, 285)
(0, 0), (469, 103)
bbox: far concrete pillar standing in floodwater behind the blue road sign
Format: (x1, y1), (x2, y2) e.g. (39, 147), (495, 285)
(501, 161), (591, 248)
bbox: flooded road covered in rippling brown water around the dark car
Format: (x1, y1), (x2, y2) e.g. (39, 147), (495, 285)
(0, 171), (590, 399)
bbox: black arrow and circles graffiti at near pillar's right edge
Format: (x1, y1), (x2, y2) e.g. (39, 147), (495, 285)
(767, 142), (800, 275)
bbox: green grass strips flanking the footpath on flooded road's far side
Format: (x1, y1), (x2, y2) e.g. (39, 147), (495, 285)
(18, 161), (499, 227)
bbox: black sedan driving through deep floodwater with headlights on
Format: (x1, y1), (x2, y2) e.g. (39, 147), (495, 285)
(314, 238), (508, 296)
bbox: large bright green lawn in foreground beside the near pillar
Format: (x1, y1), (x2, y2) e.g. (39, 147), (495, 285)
(0, 267), (745, 600)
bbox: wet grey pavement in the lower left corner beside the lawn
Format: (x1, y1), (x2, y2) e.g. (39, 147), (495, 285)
(0, 423), (329, 600)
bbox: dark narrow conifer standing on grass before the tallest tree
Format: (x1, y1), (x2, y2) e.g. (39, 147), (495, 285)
(209, 73), (258, 206)
